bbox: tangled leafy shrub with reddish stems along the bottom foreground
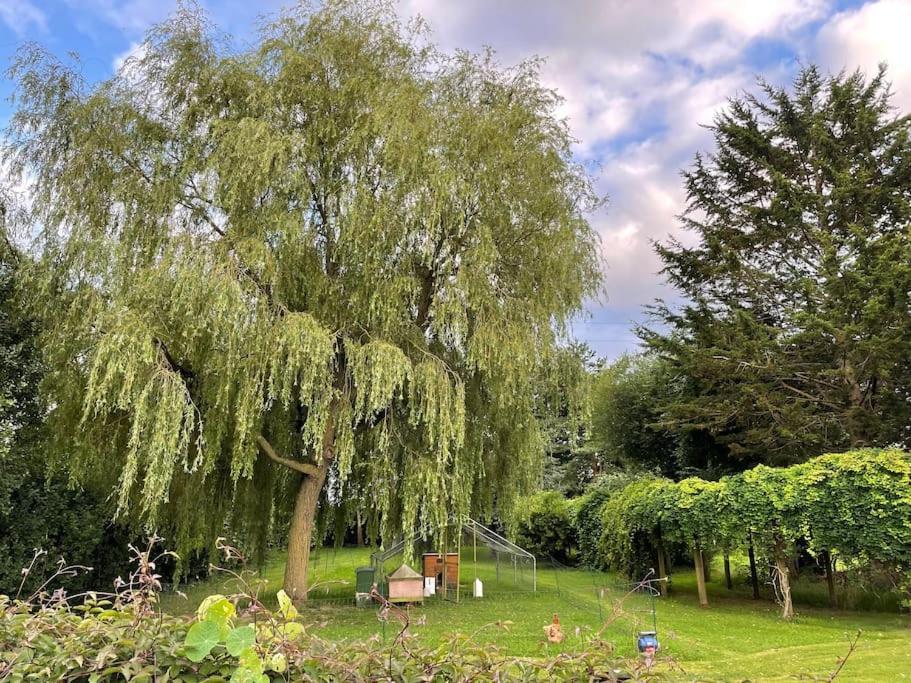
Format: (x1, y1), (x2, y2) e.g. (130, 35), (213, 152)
(0, 544), (656, 683)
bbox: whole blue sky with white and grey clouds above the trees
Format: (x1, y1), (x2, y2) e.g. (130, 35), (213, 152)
(0, 0), (911, 358)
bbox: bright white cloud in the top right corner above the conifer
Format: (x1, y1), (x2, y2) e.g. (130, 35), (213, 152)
(818, 0), (911, 113)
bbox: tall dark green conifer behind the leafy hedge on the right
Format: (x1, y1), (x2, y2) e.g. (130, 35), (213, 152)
(641, 67), (911, 464)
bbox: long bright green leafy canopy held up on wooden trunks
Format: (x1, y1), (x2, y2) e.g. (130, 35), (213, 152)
(601, 449), (911, 616)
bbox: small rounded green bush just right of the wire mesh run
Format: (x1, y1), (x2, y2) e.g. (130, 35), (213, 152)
(516, 491), (579, 565)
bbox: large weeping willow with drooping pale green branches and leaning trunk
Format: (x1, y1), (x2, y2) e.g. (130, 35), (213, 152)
(7, 2), (599, 599)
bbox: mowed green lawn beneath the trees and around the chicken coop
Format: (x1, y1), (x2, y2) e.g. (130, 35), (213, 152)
(163, 548), (911, 681)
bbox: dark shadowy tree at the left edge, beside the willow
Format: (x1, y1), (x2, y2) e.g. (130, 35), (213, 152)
(0, 218), (130, 595)
